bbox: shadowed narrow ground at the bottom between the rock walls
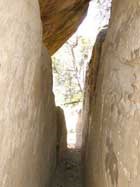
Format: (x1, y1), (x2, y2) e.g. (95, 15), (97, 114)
(52, 149), (83, 187)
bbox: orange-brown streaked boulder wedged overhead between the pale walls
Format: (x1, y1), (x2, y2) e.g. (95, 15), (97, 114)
(39, 0), (89, 55)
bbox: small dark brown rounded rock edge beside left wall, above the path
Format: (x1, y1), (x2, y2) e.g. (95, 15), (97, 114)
(56, 106), (67, 160)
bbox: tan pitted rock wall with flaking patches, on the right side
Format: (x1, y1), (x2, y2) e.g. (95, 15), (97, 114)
(83, 0), (140, 187)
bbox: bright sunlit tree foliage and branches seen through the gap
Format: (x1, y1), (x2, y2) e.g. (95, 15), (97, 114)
(52, 36), (91, 106)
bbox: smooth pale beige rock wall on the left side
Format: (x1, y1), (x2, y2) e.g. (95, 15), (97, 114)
(0, 0), (56, 187)
